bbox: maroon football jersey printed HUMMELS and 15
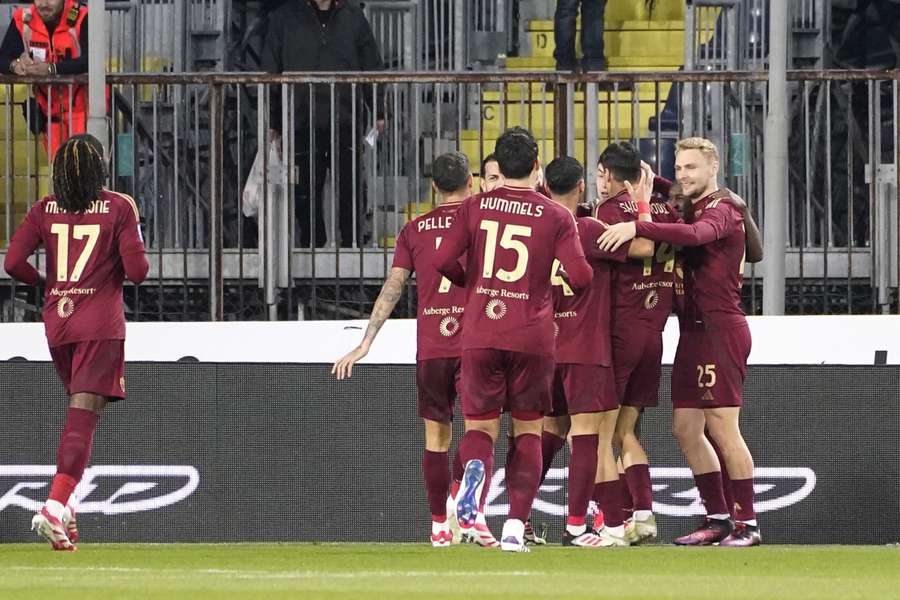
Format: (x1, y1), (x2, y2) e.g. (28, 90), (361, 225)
(436, 186), (591, 356)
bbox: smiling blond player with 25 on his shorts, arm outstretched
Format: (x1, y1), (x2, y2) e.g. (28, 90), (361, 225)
(601, 138), (761, 547)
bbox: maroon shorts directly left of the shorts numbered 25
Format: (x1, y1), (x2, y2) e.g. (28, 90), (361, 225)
(612, 325), (662, 408)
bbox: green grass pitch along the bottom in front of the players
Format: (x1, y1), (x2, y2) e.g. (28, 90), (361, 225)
(0, 544), (900, 600)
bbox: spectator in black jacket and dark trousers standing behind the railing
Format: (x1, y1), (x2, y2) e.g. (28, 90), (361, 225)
(262, 0), (384, 248)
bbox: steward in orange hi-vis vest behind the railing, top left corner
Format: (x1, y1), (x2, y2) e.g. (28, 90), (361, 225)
(0, 0), (88, 160)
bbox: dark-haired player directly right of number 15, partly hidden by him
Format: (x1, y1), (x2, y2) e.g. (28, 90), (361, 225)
(541, 156), (653, 548)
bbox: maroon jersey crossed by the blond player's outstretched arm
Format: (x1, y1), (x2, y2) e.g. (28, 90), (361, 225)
(596, 191), (678, 331)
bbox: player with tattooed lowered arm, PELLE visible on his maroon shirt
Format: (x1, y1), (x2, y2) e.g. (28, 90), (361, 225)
(331, 152), (486, 547)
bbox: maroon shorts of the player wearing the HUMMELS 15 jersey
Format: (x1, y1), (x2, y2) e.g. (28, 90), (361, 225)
(461, 348), (555, 417)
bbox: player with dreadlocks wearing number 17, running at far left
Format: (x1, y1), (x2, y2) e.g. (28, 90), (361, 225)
(4, 134), (149, 550)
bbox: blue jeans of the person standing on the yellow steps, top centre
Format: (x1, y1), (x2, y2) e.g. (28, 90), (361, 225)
(553, 0), (606, 71)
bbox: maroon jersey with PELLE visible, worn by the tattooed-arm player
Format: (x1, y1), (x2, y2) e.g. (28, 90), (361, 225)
(394, 202), (466, 360)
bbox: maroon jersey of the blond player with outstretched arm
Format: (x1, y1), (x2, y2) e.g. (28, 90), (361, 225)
(637, 189), (746, 329)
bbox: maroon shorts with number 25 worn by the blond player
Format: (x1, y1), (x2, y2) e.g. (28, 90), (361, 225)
(672, 325), (751, 408)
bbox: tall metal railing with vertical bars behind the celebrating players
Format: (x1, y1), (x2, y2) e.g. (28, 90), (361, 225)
(0, 71), (900, 319)
